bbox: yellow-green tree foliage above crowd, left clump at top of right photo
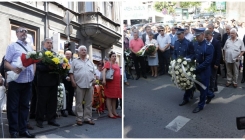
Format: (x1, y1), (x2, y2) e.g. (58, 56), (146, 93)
(154, 1), (176, 14)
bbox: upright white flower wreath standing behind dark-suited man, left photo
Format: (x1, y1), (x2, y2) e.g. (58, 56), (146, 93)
(57, 83), (66, 111)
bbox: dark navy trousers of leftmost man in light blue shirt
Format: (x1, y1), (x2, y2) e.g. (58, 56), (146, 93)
(7, 81), (32, 134)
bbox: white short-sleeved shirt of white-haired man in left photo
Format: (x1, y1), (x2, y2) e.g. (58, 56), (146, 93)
(69, 58), (96, 88)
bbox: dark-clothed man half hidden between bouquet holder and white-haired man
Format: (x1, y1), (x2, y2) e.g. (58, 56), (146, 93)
(61, 50), (76, 116)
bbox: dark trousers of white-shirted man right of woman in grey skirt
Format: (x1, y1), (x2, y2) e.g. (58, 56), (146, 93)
(158, 50), (170, 74)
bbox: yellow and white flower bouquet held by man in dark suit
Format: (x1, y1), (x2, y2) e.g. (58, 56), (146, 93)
(42, 51), (70, 75)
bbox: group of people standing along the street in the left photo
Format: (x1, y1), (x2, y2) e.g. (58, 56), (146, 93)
(0, 27), (122, 138)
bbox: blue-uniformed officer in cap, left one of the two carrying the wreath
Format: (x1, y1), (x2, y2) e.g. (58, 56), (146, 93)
(172, 28), (194, 106)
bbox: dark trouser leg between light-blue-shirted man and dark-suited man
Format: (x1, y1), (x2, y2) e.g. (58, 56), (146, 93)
(30, 83), (37, 116)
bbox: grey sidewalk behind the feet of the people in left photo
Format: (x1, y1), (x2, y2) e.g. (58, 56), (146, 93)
(0, 107), (119, 138)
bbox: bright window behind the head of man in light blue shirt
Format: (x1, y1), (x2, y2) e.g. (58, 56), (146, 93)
(10, 24), (37, 50)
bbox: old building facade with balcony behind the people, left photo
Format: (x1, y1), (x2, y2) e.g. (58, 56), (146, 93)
(0, 1), (122, 65)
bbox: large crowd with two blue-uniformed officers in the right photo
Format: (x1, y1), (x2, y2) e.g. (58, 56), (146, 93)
(124, 17), (245, 113)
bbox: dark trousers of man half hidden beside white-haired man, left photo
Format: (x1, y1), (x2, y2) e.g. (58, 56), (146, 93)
(64, 82), (74, 111)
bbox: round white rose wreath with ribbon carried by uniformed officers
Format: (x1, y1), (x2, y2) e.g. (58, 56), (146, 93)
(169, 57), (206, 90)
